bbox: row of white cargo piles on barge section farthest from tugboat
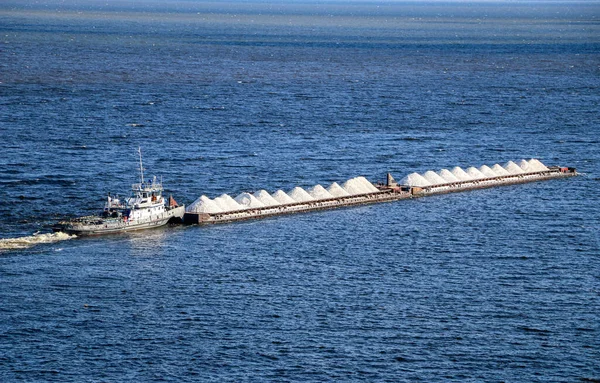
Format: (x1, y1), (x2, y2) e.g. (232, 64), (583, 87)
(400, 158), (548, 188)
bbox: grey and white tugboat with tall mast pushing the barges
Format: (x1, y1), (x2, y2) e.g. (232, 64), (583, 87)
(52, 148), (185, 236)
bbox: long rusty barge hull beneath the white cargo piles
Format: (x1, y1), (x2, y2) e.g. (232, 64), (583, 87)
(183, 166), (578, 225)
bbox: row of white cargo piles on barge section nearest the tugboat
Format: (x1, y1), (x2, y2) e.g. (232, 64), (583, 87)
(186, 177), (379, 213)
